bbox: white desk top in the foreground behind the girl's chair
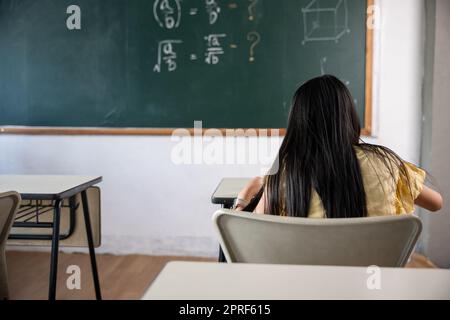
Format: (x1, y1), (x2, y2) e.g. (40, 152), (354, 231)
(142, 262), (450, 300)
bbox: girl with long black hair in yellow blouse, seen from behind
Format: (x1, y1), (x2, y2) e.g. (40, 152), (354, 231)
(235, 75), (443, 218)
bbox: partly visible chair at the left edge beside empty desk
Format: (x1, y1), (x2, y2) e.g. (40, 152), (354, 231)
(0, 192), (21, 300)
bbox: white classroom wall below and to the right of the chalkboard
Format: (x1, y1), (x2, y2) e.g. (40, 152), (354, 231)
(0, 0), (424, 256)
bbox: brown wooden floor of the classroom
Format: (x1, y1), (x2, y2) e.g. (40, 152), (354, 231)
(6, 251), (435, 300)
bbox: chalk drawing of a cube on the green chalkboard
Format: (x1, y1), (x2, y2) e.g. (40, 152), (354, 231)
(302, 0), (350, 44)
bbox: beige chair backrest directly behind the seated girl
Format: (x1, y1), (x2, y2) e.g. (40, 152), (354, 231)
(213, 209), (422, 267)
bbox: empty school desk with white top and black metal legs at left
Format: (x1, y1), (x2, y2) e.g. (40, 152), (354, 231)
(0, 175), (102, 300)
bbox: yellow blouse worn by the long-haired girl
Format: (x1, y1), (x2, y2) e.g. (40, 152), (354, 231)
(282, 148), (426, 218)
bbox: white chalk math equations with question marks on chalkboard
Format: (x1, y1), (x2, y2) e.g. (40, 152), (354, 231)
(153, 0), (261, 73)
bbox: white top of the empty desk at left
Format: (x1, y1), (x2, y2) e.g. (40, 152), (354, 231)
(0, 175), (102, 200)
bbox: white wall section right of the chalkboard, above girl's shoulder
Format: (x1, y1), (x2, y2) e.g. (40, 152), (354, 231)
(374, 0), (425, 163)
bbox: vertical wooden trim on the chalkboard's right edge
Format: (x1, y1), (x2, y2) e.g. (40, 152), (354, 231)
(361, 0), (375, 136)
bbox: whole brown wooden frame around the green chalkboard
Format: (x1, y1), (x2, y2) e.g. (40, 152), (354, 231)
(0, 0), (375, 136)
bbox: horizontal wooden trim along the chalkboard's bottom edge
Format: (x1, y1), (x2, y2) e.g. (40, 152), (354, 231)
(0, 126), (286, 137)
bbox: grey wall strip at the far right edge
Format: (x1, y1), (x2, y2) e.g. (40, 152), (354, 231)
(422, 0), (450, 268)
